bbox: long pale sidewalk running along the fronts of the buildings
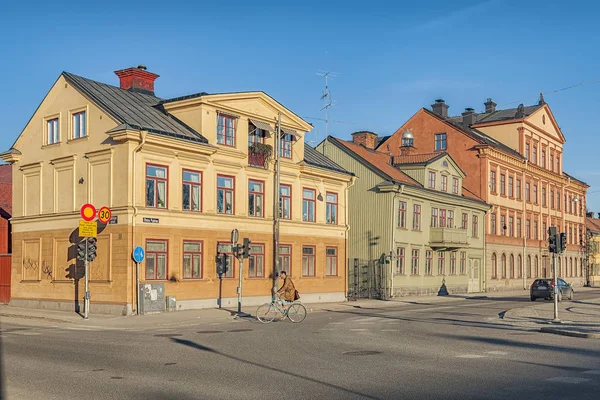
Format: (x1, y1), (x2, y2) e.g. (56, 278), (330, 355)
(0, 290), (576, 330)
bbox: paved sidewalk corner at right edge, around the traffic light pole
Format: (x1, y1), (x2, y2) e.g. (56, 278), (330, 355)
(503, 296), (600, 339)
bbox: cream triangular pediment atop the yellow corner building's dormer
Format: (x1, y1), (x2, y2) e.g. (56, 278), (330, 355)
(204, 92), (312, 134)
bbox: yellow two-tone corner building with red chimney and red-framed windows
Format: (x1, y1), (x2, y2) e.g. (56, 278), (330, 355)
(0, 66), (353, 314)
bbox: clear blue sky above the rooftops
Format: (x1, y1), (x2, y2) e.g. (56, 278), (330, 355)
(0, 0), (600, 212)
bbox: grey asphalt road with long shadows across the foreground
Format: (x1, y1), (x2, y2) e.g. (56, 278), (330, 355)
(0, 290), (600, 400)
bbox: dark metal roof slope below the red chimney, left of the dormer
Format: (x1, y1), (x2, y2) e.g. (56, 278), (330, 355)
(63, 72), (208, 143)
